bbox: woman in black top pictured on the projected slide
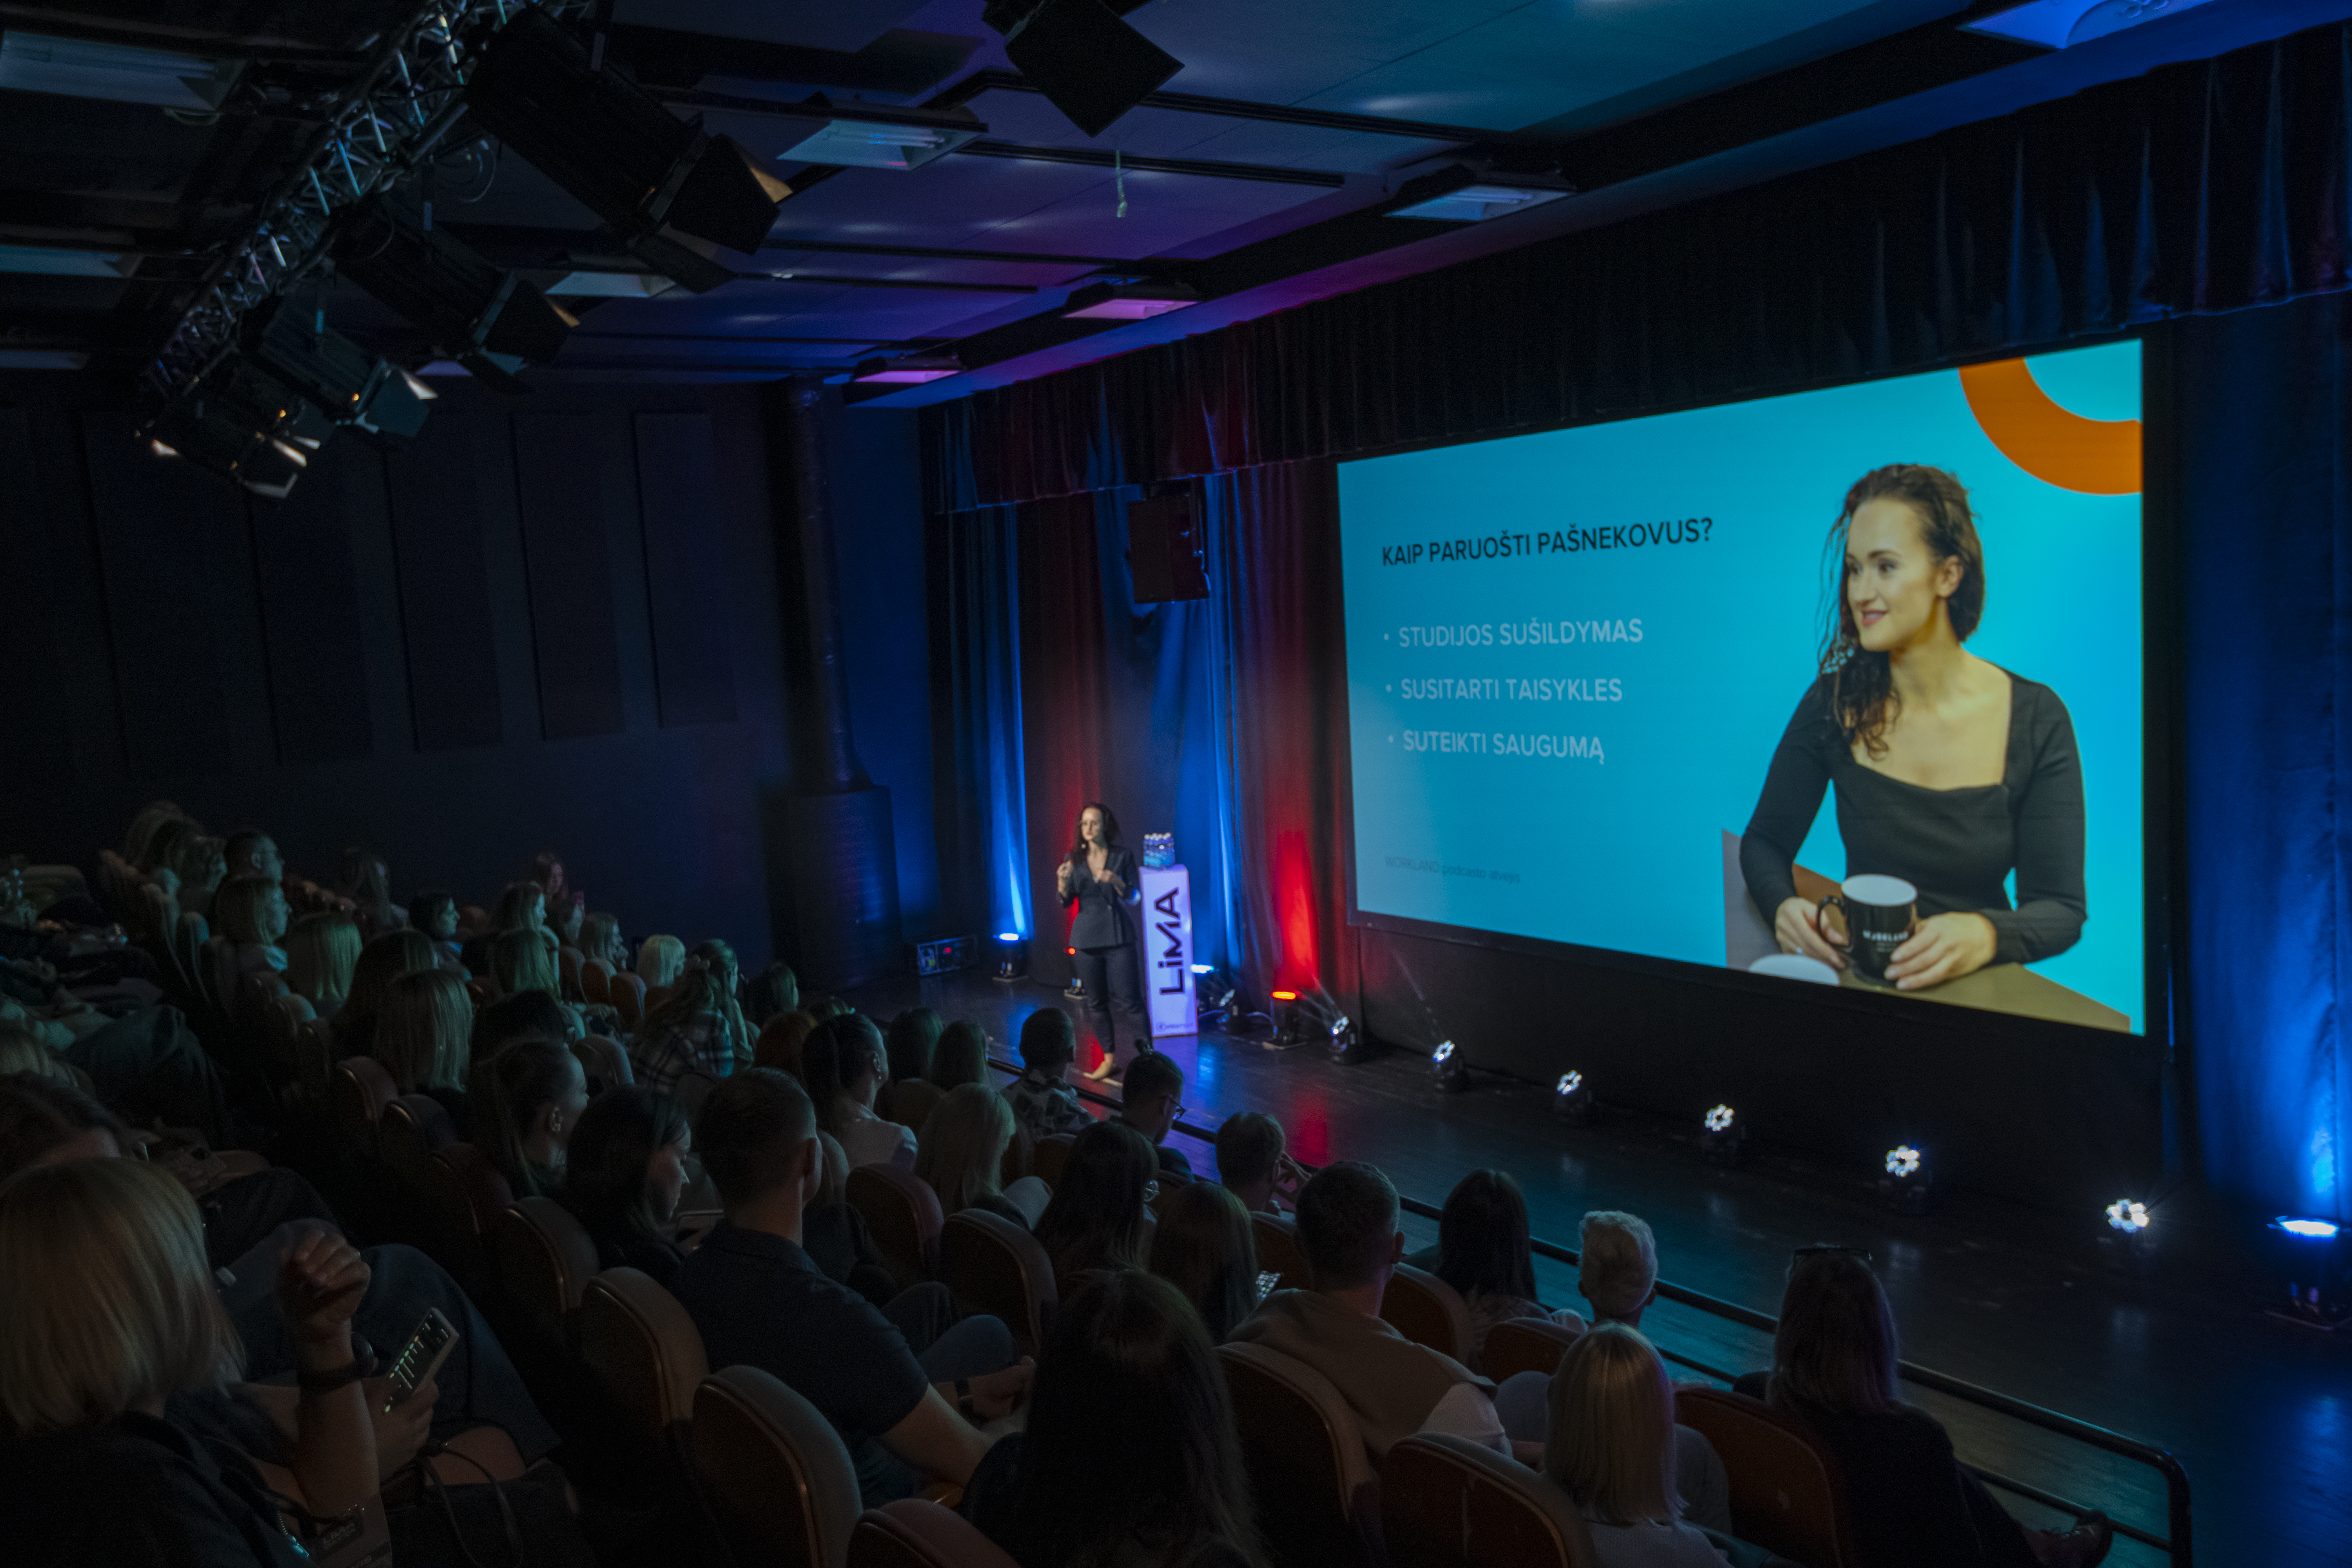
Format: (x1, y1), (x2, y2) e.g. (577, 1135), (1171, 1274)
(1740, 463), (2086, 990)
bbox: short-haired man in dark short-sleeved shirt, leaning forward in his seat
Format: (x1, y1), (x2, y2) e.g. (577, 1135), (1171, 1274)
(670, 1067), (1030, 1507)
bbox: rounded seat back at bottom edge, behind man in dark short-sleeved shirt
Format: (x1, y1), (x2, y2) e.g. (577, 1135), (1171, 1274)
(691, 1366), (858, 1568)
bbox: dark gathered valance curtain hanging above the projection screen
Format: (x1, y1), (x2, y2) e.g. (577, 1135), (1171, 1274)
(924, 24), (2352, 512)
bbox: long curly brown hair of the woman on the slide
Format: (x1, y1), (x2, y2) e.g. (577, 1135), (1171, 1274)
(1820, 463), (1985, 757)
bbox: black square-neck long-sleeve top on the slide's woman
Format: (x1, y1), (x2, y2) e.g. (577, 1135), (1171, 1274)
(1740, 675), (2089, 964)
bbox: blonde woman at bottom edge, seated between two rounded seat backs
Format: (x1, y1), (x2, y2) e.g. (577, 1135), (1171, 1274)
(1543, 1323), (1726, 1568)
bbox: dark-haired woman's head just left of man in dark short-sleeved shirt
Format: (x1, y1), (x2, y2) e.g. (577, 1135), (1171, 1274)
(557, 1084), (694, 1283)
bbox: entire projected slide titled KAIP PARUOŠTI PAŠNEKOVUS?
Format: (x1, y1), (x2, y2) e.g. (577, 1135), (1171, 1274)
(1338, 341), (2145, 1032)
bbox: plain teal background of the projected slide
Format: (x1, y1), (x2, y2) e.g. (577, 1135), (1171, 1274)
(1338, 343), (2145, 1032)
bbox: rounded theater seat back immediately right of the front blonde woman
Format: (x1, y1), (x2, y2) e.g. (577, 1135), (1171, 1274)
(1675, 1389), (1860, 1568)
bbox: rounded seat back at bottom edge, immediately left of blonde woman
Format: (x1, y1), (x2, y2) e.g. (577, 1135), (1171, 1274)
(1381, 1434), (1599, 1568)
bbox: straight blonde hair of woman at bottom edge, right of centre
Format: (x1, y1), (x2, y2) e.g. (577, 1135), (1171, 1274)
(1543, 1323), (1682, 1526)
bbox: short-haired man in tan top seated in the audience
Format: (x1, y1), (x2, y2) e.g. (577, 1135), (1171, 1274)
(1228, 1161), (1510, 1467)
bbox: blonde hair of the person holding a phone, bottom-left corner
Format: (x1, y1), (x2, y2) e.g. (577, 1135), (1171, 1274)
(0, 1159), (242, 1436)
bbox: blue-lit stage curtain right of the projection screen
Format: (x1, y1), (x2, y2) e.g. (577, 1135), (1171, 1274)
(2173, 296), (2352, 1220)
